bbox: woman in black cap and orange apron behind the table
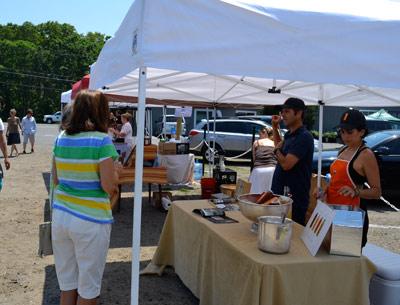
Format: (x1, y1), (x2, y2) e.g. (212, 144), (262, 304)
(325, 110), (381, 246)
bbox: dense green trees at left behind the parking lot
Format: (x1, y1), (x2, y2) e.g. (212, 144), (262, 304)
(0, 21), (109, 121)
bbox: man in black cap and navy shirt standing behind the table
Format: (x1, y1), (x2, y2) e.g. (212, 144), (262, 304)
(271, 98), (314, 225)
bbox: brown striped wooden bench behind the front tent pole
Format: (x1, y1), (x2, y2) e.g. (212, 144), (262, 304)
(111, 145), (168, 211)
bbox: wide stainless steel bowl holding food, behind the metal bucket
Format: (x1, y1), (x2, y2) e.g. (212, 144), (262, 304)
(238, 194), (293, 223)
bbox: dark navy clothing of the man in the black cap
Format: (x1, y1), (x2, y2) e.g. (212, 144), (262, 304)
(271, 126), (314, 224)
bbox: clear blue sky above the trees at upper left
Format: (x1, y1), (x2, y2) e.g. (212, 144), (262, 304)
(0, 0), (133, 36)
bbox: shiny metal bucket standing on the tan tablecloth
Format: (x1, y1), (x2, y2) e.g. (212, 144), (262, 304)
(258, 216), (293, 254)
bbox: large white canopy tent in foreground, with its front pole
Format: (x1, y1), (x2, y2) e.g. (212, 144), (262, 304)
(90, 0), (400, 304)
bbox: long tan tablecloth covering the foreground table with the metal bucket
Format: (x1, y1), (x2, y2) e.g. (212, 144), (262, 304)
(149, 201), (375, 305)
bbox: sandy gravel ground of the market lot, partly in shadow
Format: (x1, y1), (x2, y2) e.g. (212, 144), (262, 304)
(0, 124), (400, 305)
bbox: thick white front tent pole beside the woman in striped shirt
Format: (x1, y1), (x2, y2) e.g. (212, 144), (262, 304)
(131, 67), (147, 305)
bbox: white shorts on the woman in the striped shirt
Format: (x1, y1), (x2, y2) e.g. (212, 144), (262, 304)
(51, 209), (111, 299)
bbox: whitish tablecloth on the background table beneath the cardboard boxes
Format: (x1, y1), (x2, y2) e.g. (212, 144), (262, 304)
(158, 154), (194, 183)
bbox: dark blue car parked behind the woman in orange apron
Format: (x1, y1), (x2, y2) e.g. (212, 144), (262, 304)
(313, 130), (400, 197)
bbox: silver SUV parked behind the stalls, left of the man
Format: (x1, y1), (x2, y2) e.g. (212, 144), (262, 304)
(189, 119), (271, 161)
